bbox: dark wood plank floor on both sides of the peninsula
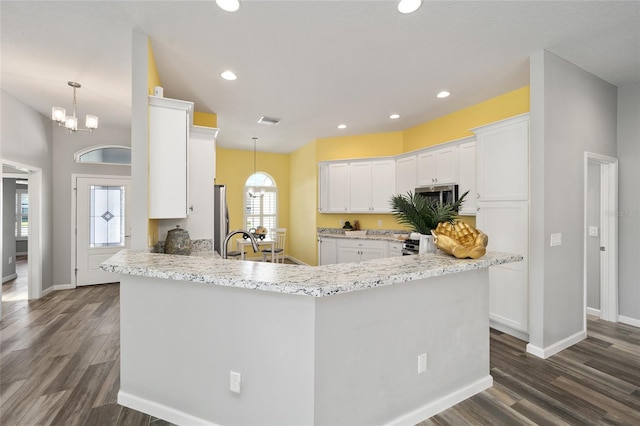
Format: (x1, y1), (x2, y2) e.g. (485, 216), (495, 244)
(0, 262), (640, 426)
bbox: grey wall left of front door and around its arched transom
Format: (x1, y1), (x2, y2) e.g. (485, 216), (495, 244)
(53, 126), (131, 285)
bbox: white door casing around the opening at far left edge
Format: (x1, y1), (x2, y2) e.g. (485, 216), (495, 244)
(0, 158), (44, 300)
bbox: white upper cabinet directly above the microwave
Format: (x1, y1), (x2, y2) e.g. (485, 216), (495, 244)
(417, 146), (458, 186)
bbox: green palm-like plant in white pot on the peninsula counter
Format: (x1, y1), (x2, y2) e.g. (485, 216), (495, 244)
(390, 191), (469, 253)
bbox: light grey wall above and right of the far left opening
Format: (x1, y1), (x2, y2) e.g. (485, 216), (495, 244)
(0, 90), (53, 290)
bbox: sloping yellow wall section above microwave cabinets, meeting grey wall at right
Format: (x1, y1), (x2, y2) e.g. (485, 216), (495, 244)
(403, 86), (529, 152)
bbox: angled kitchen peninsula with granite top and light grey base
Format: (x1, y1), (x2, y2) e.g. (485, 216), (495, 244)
(102, 250), (522, 425)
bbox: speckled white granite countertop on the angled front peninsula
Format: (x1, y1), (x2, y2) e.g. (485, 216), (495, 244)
(100, 249), (522, 297)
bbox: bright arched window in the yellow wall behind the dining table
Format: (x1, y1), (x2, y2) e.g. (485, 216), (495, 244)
(244, 172), (278, 232)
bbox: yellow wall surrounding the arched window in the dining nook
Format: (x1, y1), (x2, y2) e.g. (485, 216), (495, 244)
(216, 148), (292, 252)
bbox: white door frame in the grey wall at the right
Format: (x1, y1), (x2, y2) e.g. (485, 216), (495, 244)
(583, 152), (618, 326)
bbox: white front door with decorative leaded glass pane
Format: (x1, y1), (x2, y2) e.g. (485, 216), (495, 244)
(76, 177), (131, 286)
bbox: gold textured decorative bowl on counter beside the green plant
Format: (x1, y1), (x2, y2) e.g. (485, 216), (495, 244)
(431, 221), (489, 259)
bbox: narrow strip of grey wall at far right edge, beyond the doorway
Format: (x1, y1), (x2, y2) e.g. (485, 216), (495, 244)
(618, 83), (640, 325)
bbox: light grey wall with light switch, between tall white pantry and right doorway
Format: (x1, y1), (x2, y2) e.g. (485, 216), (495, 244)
(529, 51), (617, 350)
